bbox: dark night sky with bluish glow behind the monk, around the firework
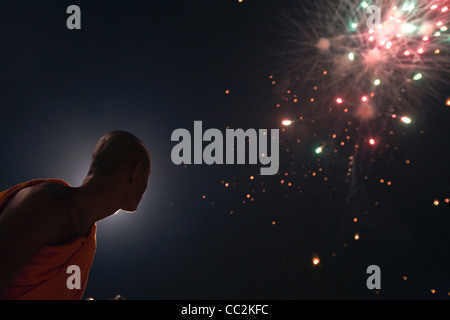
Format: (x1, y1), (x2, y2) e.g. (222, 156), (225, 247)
(0, 0), (450, 299)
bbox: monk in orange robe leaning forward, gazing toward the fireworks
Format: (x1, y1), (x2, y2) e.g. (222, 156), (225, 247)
(0, 131), (151, 300)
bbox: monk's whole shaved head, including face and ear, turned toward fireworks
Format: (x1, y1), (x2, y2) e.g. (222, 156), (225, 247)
(88, 130), (151, 211)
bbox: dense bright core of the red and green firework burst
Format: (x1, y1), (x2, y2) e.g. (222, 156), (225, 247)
(272, 0), (450, 129)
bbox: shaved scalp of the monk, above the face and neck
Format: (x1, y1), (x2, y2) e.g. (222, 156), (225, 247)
(88, 130), (150, 175)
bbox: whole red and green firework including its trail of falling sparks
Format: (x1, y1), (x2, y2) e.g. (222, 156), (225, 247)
(262, 0), (450, 280)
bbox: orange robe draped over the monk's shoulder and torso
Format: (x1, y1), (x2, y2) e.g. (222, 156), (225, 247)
(0, 179), (96, 300)
